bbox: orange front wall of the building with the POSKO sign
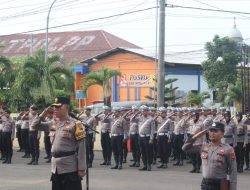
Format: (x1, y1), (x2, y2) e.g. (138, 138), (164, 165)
(76, 53), (155, 108)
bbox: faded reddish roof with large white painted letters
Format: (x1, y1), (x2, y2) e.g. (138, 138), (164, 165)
(0, 30), (140, 64)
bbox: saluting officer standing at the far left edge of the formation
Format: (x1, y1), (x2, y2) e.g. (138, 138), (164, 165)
(2, 110), (15, 164)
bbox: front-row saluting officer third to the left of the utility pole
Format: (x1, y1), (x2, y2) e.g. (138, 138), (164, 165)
(111, 108), (127, 169)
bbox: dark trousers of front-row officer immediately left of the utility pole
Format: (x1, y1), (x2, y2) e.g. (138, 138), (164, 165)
(139, 137), (153, 166)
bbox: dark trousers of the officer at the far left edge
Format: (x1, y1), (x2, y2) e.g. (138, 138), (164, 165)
(2, 132), (13, 161)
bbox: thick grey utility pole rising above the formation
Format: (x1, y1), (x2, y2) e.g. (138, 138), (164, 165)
(157, 0), (165, 107)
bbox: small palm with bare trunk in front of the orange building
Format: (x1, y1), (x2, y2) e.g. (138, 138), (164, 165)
(83, 67), (122, 106)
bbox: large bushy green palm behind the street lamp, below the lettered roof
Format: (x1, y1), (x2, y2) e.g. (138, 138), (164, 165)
(13, 49), (73, 103)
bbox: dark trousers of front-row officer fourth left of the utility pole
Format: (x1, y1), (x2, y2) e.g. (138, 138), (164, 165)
(101, 132), (112, 162)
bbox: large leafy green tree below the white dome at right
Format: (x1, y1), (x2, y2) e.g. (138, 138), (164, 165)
(202, 35), (241, 94)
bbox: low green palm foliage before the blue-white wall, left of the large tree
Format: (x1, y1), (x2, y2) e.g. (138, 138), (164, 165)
(184, 91), (210, 107)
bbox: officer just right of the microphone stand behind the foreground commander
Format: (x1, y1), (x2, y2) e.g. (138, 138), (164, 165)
(81, 107), (97, 168)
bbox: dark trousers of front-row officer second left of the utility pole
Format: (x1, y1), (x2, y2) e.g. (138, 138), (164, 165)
(130, 134), (141, 163)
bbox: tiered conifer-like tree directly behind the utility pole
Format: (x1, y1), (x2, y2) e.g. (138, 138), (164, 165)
(145, 78), (180, 107)
